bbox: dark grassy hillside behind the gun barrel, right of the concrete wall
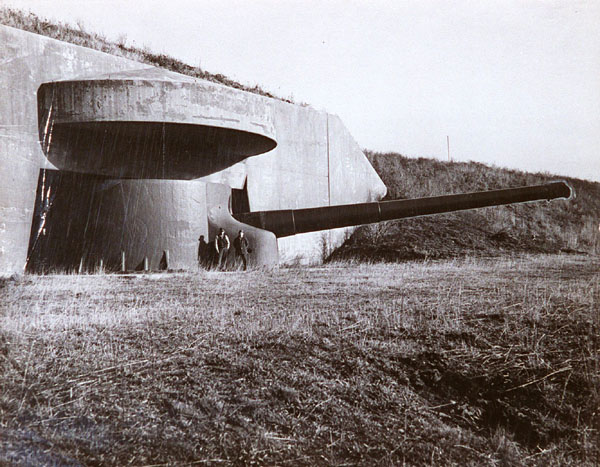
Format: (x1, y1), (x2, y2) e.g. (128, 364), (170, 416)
(330, 152), (600, 261)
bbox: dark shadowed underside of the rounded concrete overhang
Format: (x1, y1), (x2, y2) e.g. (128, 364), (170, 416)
(42, 122), (277, 180)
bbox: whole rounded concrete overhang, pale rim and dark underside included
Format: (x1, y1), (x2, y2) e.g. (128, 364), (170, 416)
(38, 68), (277, 179)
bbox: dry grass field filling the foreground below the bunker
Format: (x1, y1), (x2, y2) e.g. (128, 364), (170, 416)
(0, 255), (600, 465)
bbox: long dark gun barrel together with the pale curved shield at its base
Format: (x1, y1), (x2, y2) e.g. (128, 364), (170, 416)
(209, 181), (574, 265)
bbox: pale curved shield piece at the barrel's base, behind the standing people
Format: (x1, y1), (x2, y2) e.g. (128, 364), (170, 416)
(206, 183), (279, 268)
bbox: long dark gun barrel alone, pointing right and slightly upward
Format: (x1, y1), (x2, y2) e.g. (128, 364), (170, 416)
(234, 181), (573, 237)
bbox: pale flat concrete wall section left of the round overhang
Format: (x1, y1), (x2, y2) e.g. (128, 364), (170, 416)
(0, 25), (154, 274)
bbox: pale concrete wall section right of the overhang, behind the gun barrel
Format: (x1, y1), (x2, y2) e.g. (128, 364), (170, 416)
(206, 105), (387, 264)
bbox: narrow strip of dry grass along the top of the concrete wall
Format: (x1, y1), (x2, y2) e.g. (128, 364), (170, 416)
(0, 6), (291, 102)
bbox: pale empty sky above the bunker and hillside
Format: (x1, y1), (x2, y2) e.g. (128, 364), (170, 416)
(0, 0), (600, 181)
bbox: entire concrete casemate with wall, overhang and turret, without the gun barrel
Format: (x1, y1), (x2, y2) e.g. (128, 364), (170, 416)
(0, 26), (386, 273)
